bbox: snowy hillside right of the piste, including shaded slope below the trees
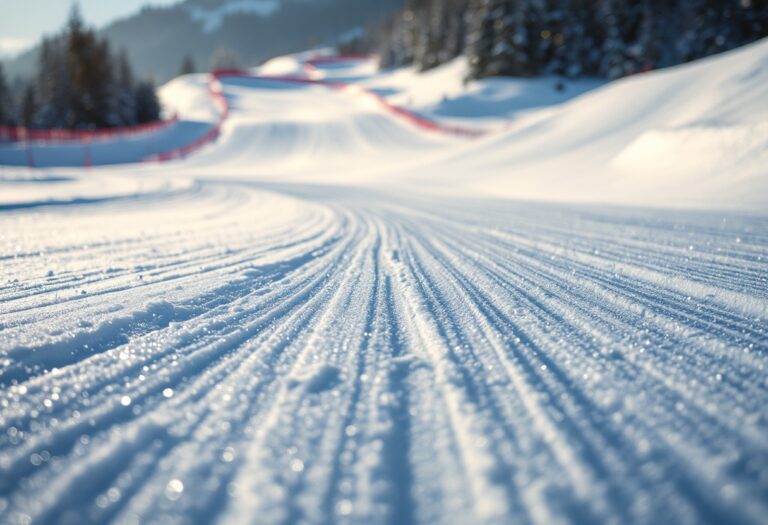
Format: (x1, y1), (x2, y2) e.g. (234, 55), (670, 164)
(365, 39), (768, 209)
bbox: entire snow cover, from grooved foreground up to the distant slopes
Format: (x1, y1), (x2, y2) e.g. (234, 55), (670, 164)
(0, 42), (768, 525)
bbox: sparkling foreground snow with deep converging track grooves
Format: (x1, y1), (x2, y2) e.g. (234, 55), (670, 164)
(0, 180), (768, 524)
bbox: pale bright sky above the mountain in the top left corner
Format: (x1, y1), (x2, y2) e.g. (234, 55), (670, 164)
(0, 0), (179, 57)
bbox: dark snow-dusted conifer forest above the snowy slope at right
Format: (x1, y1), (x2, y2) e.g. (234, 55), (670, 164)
(372, 0), (768, 79)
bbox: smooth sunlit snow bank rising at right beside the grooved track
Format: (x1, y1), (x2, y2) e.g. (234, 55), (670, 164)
(419, 41), (768, 207)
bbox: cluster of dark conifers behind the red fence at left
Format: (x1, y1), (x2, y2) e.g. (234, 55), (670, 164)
(0, 7), (161, 129)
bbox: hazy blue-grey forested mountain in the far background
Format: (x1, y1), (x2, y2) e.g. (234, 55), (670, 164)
(6, 0), (403, 82)
